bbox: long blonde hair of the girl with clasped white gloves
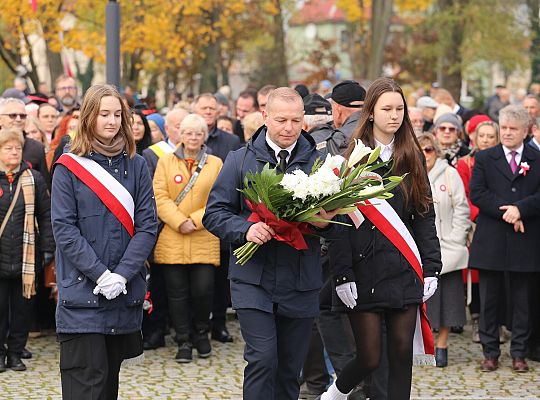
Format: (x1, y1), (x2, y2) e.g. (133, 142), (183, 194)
(70, 85), (135, 158)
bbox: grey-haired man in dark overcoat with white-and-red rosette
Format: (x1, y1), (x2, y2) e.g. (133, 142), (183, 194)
(469, 105), (540, 372)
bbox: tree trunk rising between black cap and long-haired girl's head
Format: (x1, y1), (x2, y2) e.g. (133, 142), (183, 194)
(367, 0), (394, 80)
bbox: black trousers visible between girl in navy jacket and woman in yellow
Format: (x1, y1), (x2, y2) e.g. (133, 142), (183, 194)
(142, 264), (169, 339)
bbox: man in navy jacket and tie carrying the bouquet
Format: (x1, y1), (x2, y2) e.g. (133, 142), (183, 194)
(203, 88), (339, 400)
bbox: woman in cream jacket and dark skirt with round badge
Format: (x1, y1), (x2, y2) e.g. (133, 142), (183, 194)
(418, 135), (470, 367)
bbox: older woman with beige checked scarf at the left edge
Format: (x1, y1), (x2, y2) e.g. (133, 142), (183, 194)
(0, 128), (54, 372)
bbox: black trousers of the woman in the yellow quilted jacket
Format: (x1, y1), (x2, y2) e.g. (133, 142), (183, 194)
(163, 264), (216, 344)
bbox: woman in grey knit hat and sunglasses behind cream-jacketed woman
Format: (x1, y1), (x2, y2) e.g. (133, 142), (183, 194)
(433, 113), (470, 167)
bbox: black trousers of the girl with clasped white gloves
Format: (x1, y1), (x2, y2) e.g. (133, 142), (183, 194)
(58, 333), (142, 400)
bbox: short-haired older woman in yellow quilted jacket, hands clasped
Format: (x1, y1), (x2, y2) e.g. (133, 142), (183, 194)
(154, 114), (222, 363)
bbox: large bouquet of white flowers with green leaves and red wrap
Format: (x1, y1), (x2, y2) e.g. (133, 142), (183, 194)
(234, 140), (405, 265)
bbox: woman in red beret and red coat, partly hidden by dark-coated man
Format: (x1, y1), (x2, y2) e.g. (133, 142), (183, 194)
(456, 115), (504, 343)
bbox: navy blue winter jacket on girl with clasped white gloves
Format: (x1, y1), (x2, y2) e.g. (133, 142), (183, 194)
(51, 153), (157, 334)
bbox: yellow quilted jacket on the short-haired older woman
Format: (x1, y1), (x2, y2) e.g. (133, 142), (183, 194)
(154, 150), (223, 266)
